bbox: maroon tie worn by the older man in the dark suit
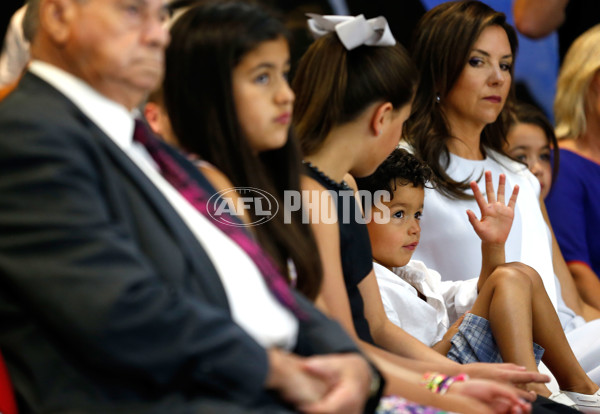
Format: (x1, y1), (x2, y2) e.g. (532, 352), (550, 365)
(133, 120), (305, 319)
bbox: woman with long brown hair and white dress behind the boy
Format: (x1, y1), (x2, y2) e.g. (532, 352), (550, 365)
(404, 1), (600, 394)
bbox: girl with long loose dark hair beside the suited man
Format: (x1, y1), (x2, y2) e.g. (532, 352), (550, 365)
(163, 0), (321, 299)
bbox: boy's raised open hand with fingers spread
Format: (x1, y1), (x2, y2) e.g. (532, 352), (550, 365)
(467, 171), (519, 244)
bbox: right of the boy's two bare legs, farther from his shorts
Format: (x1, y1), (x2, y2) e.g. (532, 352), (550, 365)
(511, 263), (598, 394)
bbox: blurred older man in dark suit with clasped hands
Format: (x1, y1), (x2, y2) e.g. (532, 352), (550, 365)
(0, 0), (381, 413)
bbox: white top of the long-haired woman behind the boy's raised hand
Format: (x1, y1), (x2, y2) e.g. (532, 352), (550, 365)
(413, 149), (558, 308)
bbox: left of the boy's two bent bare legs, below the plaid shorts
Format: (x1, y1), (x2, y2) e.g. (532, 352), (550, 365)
(471, 265), (562, 396)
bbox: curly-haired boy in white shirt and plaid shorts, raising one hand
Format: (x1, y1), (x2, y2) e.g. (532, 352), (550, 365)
(357, 149), (597, 406)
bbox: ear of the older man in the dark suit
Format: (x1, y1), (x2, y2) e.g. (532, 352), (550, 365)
(40, 0), (78, 45)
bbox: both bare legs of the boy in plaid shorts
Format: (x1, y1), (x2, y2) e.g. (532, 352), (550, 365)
(472, 263), (598, 396)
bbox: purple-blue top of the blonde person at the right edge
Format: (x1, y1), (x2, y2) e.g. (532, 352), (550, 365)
(546, 149), (600, 275)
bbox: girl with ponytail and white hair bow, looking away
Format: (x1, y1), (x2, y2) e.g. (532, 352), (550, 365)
(292, 11), (556, 413)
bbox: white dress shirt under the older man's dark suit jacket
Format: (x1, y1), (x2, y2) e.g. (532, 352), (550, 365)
(29, 61), (298, 349)
